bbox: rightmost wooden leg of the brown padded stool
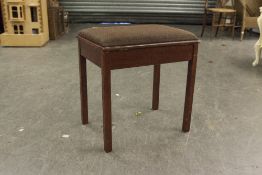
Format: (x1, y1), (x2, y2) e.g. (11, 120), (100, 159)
(182, 45), (198, 132)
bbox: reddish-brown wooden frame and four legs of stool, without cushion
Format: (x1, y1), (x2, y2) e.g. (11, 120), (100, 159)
(78, 37), (199, 153)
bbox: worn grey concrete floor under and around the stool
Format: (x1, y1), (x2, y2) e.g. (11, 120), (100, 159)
(0, 24), (262, 175)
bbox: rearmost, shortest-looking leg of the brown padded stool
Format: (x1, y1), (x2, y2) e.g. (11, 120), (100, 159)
(152, 65), (160, 110)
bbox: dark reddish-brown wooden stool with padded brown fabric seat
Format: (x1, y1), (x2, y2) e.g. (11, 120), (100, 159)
(78, 24), (199, 153)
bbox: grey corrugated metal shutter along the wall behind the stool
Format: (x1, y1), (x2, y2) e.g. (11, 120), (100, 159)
(60, 0), (216, 23)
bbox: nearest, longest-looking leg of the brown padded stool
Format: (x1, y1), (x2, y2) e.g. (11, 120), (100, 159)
(102, 63), (112, 153)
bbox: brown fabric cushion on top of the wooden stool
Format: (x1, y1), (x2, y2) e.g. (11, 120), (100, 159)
(79, 24), (198, 47)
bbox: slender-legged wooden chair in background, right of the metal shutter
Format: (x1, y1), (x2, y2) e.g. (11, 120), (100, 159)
(201, 0), (236, 38)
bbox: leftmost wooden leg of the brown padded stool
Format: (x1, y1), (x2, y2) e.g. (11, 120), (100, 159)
(79, 55), (88, 125)
